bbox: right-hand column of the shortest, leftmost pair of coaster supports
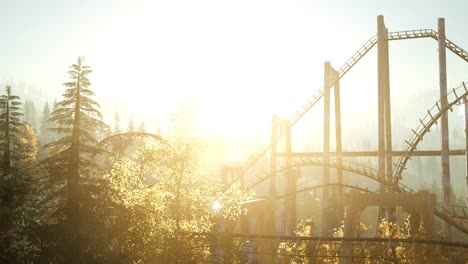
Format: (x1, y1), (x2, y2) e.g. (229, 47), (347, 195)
(281, 120), (297, 235)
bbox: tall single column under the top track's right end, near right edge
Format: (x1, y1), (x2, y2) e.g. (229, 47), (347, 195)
(438, 18), (451, 239)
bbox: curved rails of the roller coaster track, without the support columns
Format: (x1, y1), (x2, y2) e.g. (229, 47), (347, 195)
(233, 29), (468, 234)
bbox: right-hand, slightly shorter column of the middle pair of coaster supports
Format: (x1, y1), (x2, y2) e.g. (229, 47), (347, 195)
(334, 71), (344, 224)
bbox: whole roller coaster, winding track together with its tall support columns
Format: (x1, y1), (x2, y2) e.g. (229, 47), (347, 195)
(220, 17), (468, 263)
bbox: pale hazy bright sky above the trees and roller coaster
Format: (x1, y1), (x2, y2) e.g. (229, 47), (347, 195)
(0, 0), (468, 148)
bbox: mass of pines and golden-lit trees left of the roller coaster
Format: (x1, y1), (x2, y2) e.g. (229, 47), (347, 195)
(0, 57), (254, 263)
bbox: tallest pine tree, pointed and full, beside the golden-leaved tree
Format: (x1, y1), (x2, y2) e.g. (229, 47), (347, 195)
(48, 57), (106, 262)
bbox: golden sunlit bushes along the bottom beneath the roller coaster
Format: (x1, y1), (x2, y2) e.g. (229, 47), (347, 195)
(277, 215), (455, 264)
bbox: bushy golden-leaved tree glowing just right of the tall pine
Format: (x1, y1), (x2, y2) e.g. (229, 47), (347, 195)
(90, 106), (250, 263)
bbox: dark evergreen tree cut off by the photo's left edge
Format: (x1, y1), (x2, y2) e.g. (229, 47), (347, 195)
(0, 86), (37, 263)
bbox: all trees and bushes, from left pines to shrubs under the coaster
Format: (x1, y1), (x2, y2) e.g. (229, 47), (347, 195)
(0, 57), (466, 263)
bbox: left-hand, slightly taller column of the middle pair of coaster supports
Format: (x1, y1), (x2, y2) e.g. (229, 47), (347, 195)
(322, 61), (331, 236)
